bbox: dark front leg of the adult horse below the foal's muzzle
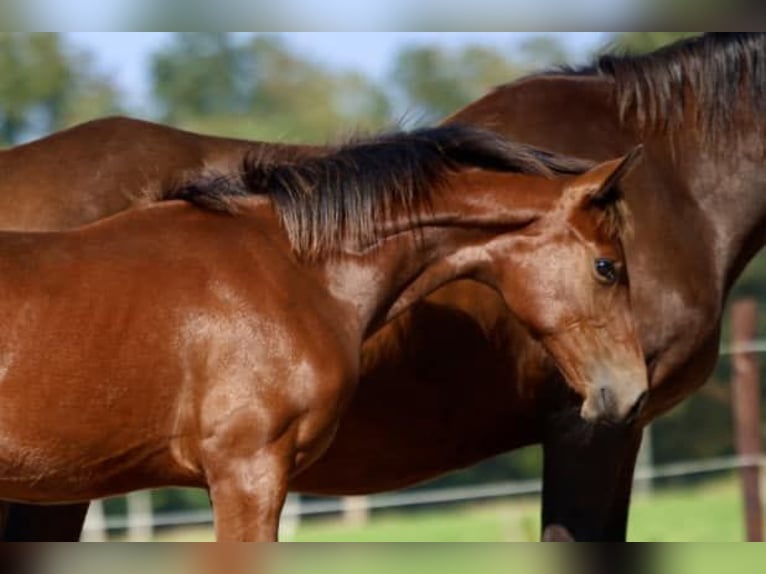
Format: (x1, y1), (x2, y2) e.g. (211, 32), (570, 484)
(542, 420), (641, 542)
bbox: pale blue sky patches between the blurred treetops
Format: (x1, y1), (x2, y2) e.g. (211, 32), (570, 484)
(66, 33), (605, 107)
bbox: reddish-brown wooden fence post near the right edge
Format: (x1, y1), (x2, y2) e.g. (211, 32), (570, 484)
(731, 299), (763, 542)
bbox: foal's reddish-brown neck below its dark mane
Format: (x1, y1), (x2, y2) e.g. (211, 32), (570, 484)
(323, 172), (557, 337)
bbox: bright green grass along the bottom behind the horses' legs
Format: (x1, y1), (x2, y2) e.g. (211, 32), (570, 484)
(150, 479), (756, 542)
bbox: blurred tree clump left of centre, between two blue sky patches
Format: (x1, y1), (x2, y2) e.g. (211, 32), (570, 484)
(152, 32), (390, 141)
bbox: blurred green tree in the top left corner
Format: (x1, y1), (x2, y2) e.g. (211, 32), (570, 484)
(0, 32), (119, 144)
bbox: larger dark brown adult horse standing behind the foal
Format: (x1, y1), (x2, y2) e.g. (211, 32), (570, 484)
(0, 34), (766, 540)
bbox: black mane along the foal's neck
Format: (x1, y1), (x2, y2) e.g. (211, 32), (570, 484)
(163, 125), (591, 259)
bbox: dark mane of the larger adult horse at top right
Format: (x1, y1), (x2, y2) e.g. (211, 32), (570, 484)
(553, 32), (766, 139)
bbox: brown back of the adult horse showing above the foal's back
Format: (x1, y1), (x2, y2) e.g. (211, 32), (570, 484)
(0, 117), (320, 231)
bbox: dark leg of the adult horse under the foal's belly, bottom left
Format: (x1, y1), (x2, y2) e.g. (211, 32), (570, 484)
(0, 502), (88, 542)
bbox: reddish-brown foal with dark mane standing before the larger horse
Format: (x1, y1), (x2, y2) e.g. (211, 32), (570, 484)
(0, 126), (646, 540)
